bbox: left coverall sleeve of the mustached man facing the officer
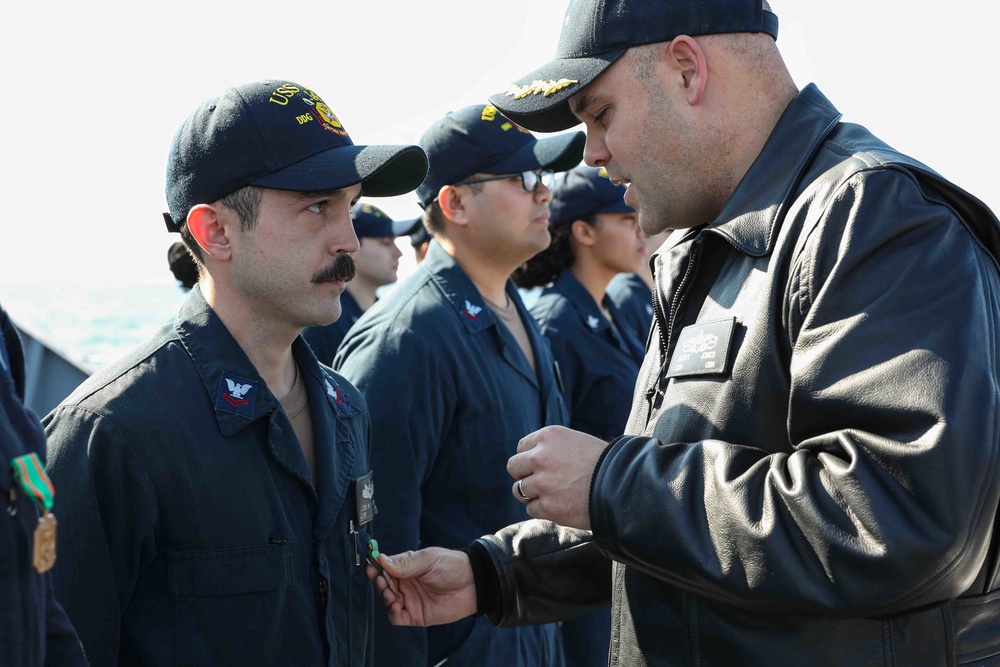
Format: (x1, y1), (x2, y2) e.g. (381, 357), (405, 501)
(43, 406), (157, 667)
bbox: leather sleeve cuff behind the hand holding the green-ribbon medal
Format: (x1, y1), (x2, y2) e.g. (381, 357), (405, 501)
(476, 519), (611, 627)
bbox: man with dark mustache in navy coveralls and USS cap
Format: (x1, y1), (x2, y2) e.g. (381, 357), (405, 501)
(44, 80), (427, 667)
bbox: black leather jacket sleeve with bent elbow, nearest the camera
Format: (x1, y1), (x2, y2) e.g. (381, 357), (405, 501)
(590, 168), (1000, 617)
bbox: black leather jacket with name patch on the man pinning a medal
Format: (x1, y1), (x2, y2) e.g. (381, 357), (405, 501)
(471, 85), (1000, 667)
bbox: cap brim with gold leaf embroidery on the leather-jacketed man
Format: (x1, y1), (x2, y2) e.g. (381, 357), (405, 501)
(490, 48), (628, 132)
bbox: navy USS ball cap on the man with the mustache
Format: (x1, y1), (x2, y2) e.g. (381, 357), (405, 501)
(166, 80), (427, 227)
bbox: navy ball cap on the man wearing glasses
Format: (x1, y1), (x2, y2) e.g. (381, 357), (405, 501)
(417, 104), (587, 207)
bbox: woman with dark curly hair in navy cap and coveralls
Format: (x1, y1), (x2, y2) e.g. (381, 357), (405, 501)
(513, 165), (646, 439)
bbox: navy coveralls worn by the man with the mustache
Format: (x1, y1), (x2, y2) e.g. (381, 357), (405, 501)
(44, 286), (374, 667)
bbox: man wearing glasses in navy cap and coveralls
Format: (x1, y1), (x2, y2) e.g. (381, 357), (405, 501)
(334, 105), (584, 667)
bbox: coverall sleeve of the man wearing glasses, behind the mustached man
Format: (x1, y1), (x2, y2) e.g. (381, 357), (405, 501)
(334, 327), (454, 667)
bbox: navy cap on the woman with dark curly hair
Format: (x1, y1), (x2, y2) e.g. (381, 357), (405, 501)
(549, 165), (635, 226)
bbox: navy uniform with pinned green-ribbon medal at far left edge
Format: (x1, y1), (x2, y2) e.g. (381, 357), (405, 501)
(0, 308), (87, 667)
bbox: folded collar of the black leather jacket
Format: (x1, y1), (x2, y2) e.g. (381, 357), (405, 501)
(704, 84), (841, 257)
